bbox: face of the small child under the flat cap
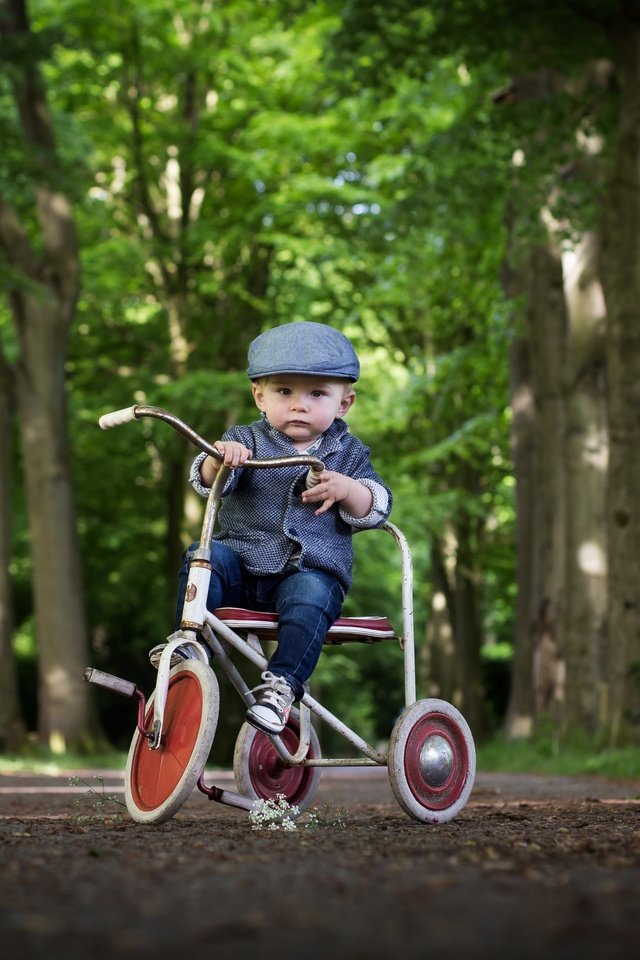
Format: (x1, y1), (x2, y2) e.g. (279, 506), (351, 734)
(253, 373), (356, 450)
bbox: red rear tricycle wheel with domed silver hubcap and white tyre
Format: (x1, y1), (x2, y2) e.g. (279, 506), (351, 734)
(389, 700), (476, 823)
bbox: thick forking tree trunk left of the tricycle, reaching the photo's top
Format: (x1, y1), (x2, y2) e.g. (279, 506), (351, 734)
(0, 0), (96, 752)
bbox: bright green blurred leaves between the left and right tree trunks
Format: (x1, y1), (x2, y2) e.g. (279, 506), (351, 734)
(12, 0), (615, 739)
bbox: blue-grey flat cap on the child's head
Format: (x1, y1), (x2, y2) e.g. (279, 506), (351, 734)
(247, 320), (360, 382)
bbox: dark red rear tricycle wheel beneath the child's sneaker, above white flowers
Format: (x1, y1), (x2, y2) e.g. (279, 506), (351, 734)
(233, 709), (321, 813)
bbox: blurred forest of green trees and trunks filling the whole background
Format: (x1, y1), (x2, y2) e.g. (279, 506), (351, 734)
(0, 0), (640, 761)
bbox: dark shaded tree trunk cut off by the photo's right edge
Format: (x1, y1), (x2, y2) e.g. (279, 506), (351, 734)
(602, 21), (640, 744)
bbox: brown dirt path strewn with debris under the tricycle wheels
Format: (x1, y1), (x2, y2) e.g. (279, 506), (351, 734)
(0, 770), (640, 960)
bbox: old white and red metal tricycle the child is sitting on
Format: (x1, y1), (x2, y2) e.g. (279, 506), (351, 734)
(84, 405), (475, 824)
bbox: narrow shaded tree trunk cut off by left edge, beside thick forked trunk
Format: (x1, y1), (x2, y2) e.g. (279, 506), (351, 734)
(0, 356), (26, 753)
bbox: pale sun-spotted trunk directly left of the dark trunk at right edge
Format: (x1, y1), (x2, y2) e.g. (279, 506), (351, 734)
(559, 235), (608, 736)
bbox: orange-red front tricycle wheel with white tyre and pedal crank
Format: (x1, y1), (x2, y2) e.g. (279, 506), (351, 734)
(125, 660), (220, 824)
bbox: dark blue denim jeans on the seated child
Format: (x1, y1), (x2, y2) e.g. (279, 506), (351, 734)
(176, 541), (342, 700)
